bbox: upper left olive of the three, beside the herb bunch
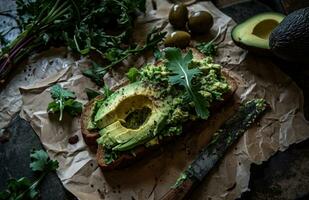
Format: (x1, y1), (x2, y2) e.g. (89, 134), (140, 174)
(168, 3), (188, 29)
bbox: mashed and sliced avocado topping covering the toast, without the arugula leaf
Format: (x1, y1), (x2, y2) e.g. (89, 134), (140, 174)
(88, 57), (230, 164)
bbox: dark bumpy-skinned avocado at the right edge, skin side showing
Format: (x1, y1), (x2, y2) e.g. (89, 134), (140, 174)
(269, 7), (309, 63)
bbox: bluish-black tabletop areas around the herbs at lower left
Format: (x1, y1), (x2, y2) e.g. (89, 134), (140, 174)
(0, 116), (75, 200)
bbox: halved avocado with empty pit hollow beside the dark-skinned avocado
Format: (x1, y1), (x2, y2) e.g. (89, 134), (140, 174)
(232, 12), (285, 53)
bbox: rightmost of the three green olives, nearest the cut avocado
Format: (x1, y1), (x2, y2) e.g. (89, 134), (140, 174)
(188, 11), (214, 34)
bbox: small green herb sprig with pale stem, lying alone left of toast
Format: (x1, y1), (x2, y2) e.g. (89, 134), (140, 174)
(47, 84), (83, 121)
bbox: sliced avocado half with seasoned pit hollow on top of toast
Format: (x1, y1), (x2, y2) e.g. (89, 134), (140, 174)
(94, 82), (172, 151)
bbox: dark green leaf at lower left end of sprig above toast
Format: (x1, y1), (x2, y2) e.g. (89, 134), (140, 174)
(83, 62), (106, 87)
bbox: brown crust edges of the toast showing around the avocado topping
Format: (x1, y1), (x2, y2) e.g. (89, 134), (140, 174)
(81, 48), (237, 170)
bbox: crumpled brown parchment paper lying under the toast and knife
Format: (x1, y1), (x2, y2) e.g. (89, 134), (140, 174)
(3, 0), (309, 200)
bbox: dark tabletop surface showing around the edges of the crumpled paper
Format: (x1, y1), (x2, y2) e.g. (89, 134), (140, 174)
(0, 0), (309, 200)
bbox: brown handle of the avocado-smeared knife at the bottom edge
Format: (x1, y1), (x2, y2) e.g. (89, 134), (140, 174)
(160, 178), (196, 200)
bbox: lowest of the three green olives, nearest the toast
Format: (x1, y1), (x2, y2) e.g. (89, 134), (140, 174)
(164, 31), (191, 48)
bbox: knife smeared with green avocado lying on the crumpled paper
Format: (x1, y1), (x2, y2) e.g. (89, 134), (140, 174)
(161, 99), (268, 200)
